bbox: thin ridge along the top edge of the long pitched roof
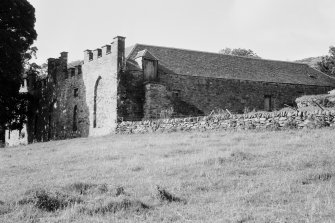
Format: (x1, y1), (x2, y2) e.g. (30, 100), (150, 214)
(134, 43), (309, 67)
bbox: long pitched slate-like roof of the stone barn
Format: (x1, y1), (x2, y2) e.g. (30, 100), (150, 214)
(126, 44), (335, 87)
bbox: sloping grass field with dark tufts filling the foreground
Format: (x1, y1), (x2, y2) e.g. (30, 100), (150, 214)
(0, 129), (335, 222)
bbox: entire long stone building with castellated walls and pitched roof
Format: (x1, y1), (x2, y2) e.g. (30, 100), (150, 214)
(4, 36), (335, 145)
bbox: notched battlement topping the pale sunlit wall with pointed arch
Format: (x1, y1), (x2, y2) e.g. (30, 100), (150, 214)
(84, 36), (125, 63)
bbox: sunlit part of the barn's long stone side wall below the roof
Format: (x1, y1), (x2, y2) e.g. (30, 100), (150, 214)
(159, 71), (331, 114)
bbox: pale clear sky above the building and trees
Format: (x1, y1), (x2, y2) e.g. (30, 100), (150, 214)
(28, 0), (335, 63)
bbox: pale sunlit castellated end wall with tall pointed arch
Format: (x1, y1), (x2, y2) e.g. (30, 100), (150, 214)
(83, 37), (125, 136)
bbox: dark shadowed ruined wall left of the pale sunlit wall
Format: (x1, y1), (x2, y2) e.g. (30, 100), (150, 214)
(27, 52), (88, 142)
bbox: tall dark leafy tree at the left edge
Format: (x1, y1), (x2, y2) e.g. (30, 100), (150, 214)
(0, 0), (37, 144)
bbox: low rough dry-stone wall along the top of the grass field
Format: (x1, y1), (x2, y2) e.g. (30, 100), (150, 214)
(116, 110), (335, 134)
